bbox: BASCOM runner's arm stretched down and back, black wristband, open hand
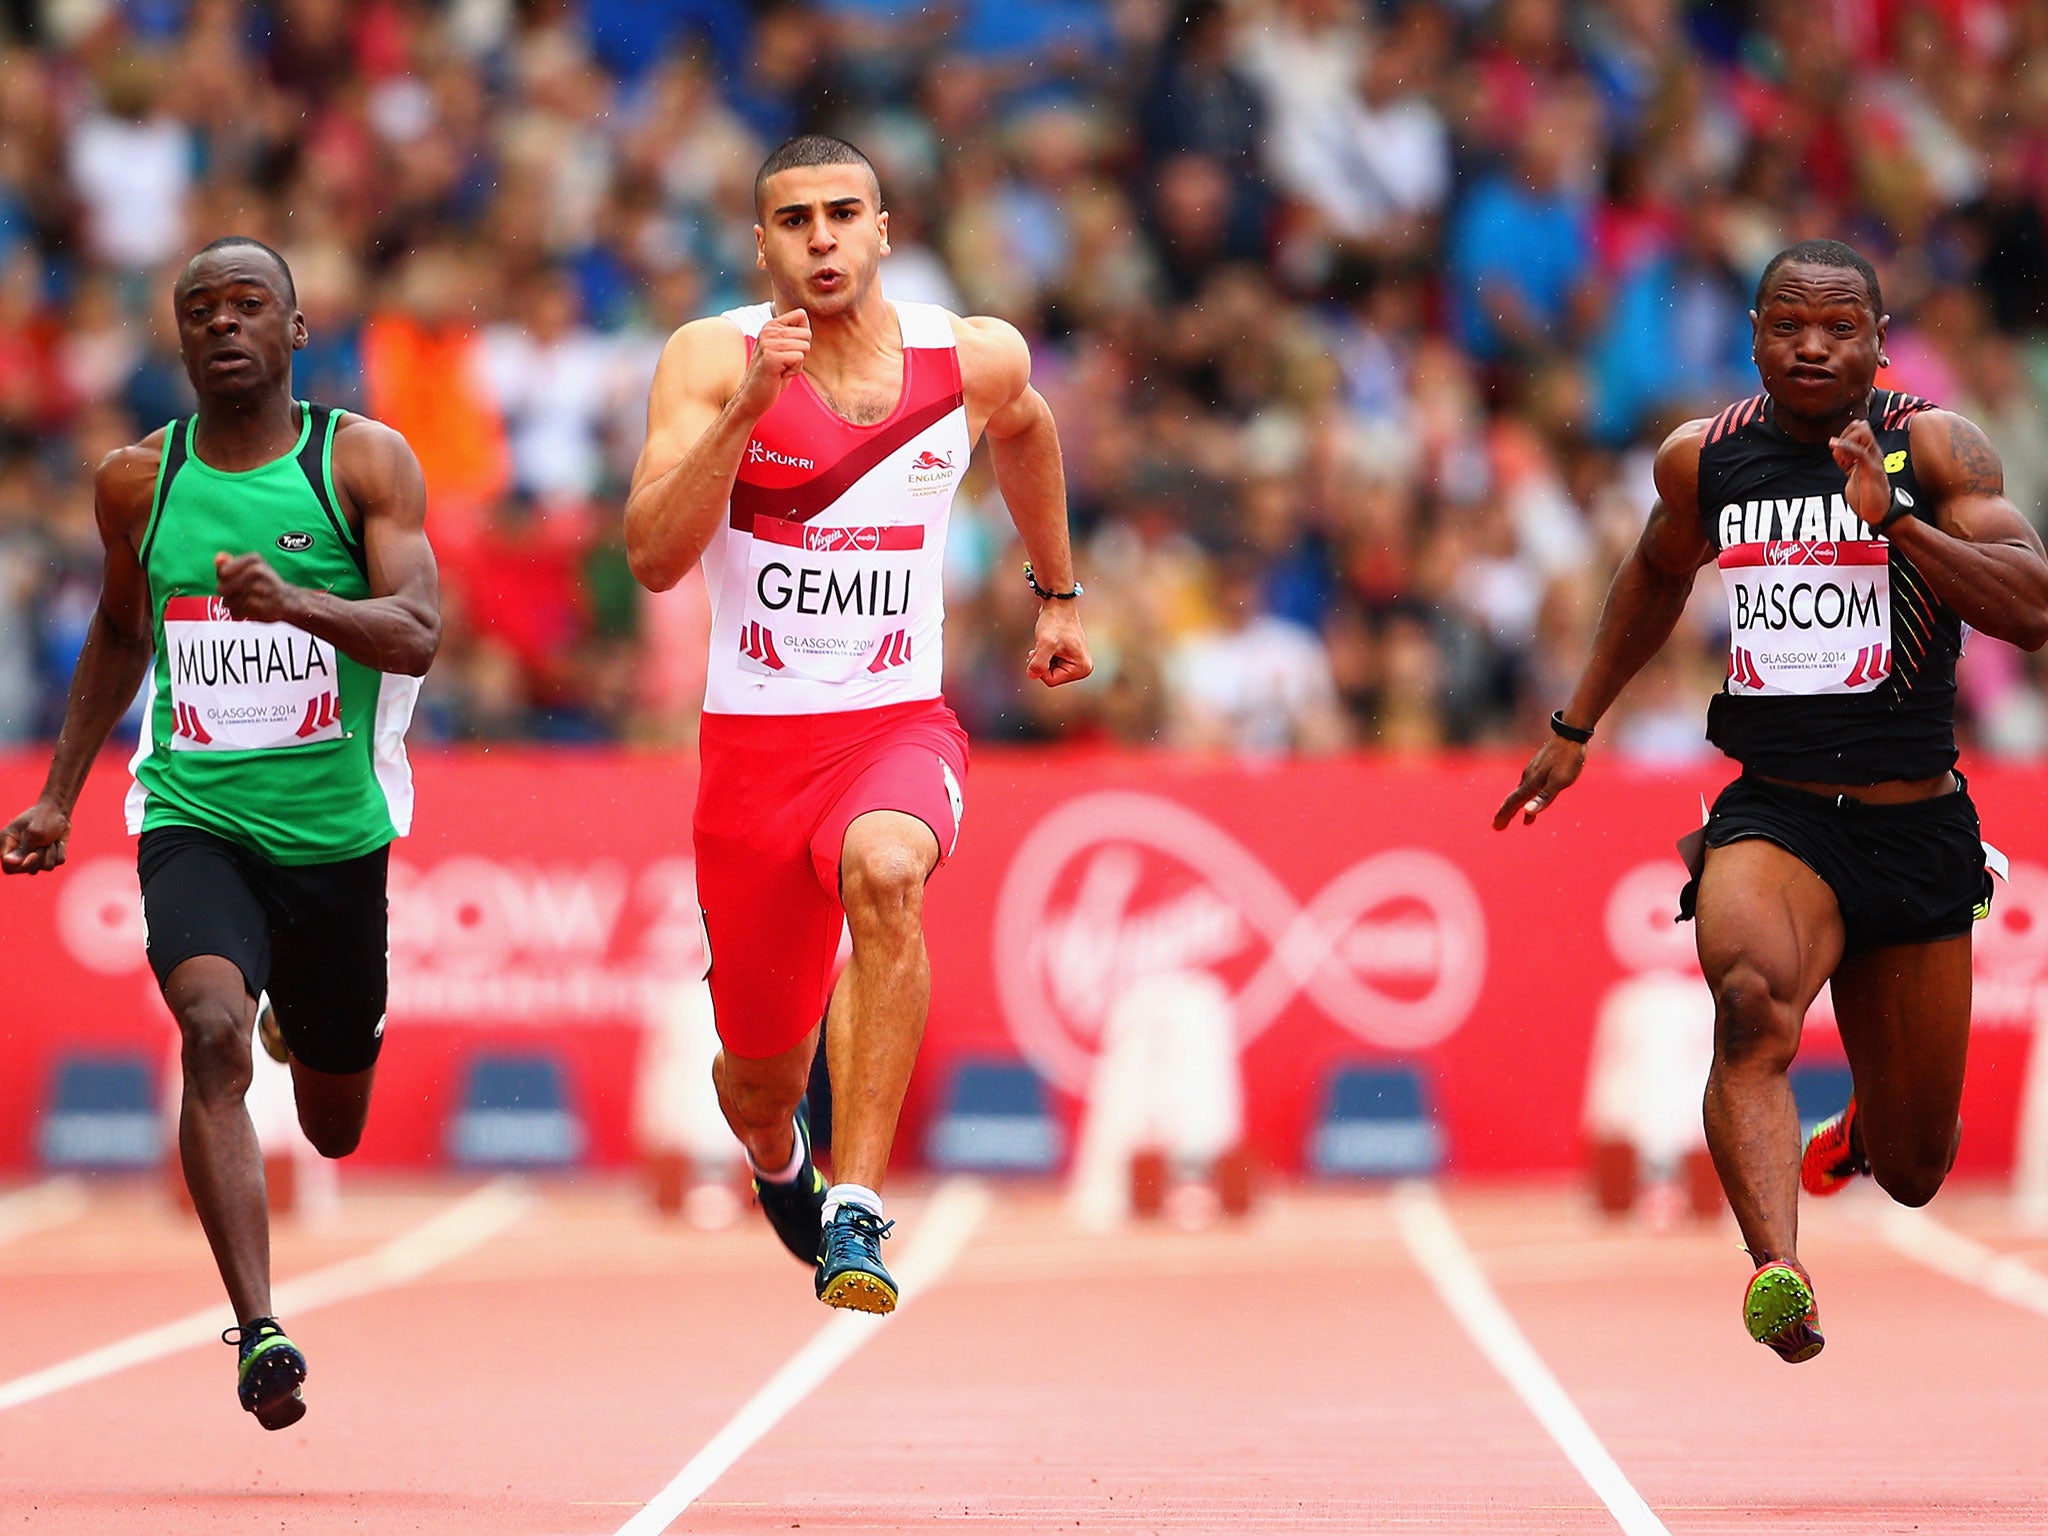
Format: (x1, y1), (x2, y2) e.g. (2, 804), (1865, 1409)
(1493, 420), (1714, 831)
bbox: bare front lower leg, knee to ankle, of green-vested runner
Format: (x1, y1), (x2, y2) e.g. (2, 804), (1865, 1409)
(164, 954), (270, 1321)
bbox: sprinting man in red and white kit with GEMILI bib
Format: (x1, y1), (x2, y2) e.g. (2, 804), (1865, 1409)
(627, 135), (1090, 1313)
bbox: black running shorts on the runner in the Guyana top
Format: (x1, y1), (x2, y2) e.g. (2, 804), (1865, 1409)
(1677, 774), (1991, 954)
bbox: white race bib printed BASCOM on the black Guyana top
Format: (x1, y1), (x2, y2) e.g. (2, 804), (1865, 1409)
(1720, 539), (1892, 694)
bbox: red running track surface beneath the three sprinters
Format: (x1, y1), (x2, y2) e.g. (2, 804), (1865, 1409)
(0, 1184), (2048, 1536)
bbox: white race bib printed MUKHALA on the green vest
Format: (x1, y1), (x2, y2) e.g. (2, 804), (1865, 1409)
(164, 598), (342, 752)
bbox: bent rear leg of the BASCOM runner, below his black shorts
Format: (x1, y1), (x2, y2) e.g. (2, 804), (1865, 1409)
(1835, 934), (1970, 1206)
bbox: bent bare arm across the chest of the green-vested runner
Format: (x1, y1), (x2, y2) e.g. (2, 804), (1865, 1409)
(213, 416), (440, 678)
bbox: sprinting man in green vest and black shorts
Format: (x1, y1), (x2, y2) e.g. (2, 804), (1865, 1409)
(0, 238), (440, 1430)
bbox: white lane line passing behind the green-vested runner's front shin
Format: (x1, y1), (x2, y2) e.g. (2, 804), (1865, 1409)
(0, 1178), (535, 1409)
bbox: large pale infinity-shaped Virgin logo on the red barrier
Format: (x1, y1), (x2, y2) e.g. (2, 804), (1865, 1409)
(993, 791), (1487, 1092)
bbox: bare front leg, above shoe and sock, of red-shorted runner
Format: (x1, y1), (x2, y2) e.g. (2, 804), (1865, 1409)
(825, 811), (940, 1190)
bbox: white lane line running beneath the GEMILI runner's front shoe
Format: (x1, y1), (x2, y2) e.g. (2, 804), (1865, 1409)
(616, 1178), (989, 1536)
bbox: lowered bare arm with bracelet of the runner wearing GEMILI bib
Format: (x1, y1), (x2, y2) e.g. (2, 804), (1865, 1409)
(952, 317), (1096, 688)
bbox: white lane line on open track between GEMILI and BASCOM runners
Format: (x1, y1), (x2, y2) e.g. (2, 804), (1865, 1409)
(1393, 1184), (1671, 1536)
